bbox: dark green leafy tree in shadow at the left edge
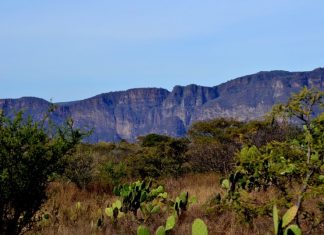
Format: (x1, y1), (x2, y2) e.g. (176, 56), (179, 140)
(0, 112), (83, 234)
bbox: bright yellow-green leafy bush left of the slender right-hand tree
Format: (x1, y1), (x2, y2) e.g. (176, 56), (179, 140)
(229, 142), (307, 194)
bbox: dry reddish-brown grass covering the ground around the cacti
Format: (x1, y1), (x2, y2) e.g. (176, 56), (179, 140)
(29, 173), (323, 235)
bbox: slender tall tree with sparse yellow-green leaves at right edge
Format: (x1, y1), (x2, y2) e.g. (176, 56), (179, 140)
(281, 87), (324, 213)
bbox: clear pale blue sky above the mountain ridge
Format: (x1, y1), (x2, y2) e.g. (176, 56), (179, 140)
(0, 0), (324, 102)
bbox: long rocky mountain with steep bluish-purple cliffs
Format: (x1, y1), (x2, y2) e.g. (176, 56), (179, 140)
(0, 68), (324, 142)
